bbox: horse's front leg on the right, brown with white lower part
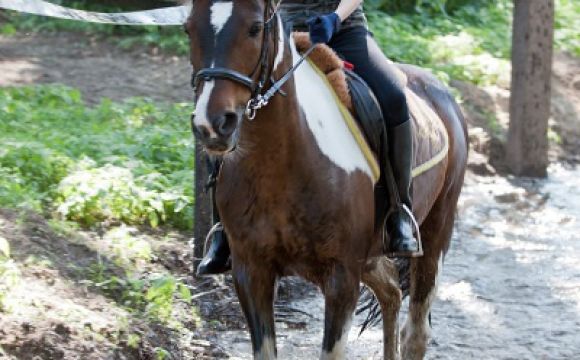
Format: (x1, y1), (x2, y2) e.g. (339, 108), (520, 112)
(320, 264), (360, 360)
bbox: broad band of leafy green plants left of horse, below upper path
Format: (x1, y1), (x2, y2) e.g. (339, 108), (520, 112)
(0, 86), (194, 229)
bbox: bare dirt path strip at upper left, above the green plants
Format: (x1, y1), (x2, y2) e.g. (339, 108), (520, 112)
(0, 34), (192, 103)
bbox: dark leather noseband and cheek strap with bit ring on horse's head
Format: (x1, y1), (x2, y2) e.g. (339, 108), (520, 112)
(192, 1), (280, 120)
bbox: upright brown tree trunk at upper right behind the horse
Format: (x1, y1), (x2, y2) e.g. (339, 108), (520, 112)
(506, 0), (554, 177)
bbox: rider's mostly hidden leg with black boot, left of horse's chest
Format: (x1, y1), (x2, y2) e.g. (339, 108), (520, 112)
(197, 159), (231, 276)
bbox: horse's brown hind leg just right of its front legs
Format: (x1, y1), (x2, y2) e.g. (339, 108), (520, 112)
(362, 257), (402, 360)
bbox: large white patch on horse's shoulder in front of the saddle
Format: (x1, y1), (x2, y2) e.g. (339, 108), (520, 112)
(290, 40), (373, 181)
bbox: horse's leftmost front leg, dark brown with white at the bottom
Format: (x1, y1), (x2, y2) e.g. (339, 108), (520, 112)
(232, 261), (276, 360)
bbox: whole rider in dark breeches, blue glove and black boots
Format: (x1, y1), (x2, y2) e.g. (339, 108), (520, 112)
(197, 0), (419, 275)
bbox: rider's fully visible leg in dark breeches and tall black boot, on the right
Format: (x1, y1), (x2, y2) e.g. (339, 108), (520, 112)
(329, 26), (419, 256)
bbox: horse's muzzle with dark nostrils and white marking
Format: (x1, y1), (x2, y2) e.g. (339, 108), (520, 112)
(191, 111), (243, 155)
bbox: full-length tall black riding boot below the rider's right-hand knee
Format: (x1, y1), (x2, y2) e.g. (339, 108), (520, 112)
(386, 121), (422, 257)
